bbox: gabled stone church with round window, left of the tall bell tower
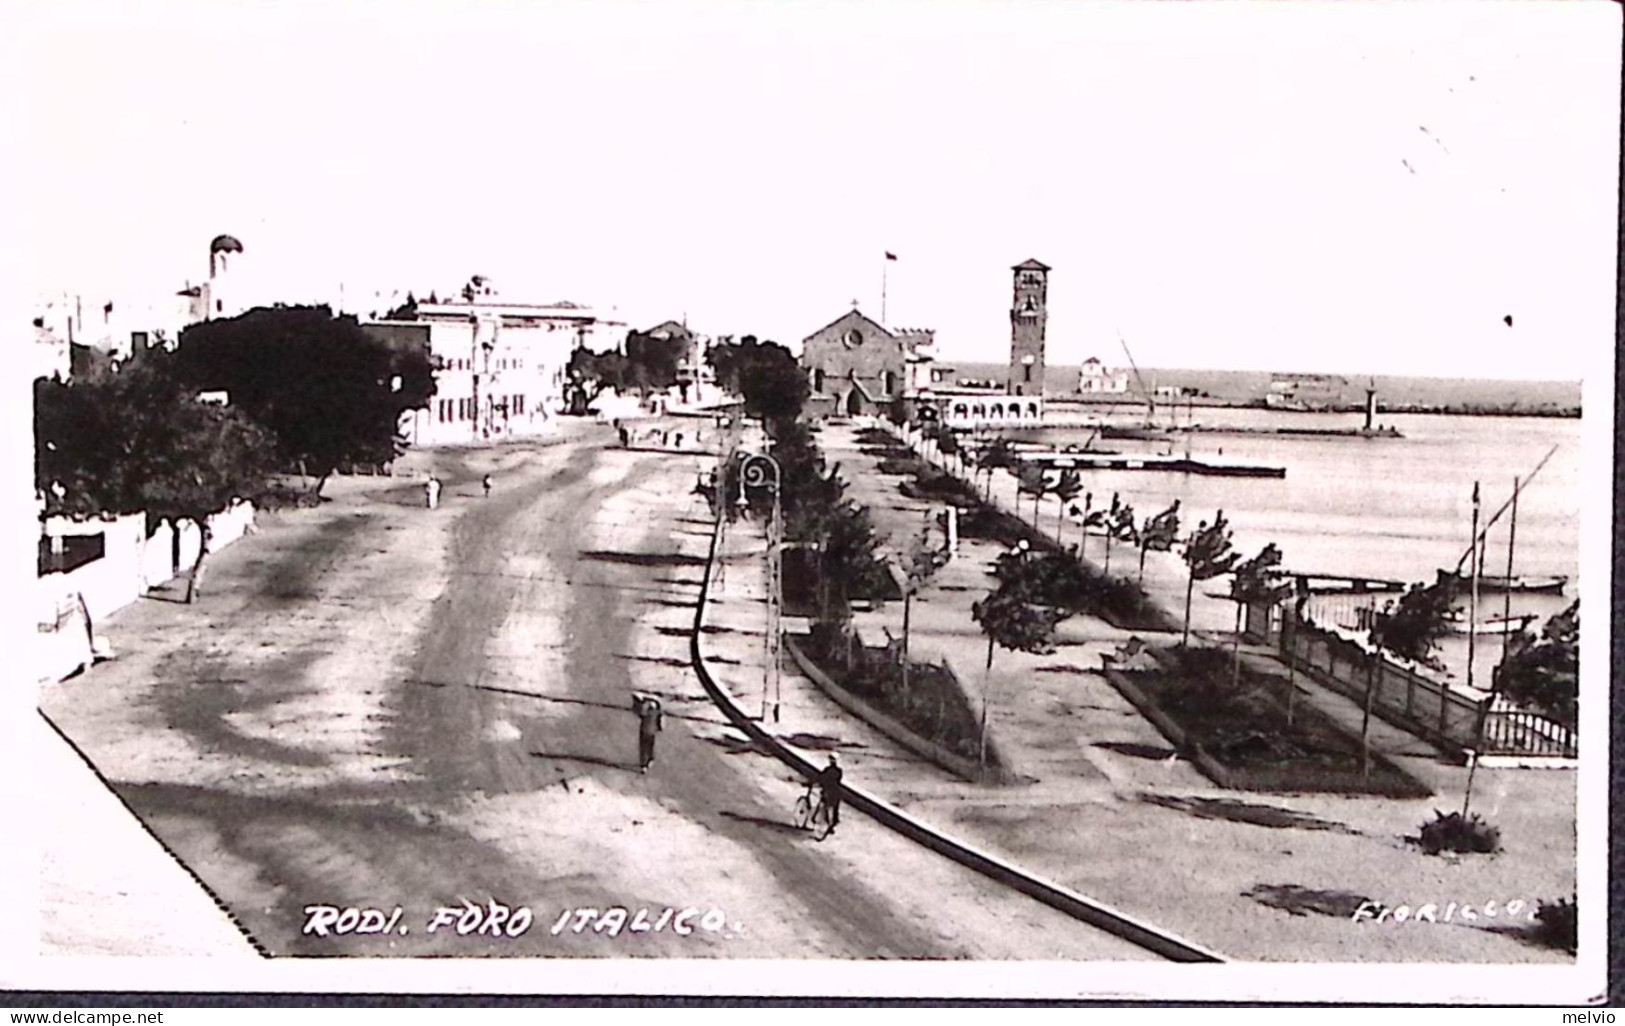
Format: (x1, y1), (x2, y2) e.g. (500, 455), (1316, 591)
(801, 309), (936, 416)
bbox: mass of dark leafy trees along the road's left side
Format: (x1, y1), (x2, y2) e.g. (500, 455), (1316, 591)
(34, 307), (434, 602)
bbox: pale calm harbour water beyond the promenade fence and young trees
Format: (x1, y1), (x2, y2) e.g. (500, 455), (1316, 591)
(1024, 408), (1581, 683)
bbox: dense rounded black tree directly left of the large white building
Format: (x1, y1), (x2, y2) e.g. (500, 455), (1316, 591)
(176, 306), (436, 494)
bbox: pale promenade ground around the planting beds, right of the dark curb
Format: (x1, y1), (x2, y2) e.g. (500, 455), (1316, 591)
(793, 424), (1575, 961)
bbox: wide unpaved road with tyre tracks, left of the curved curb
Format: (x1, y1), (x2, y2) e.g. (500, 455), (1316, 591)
(41, 428), (1142, 958)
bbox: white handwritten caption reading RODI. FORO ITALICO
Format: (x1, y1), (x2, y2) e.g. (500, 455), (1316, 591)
(302, 899), (728, 938)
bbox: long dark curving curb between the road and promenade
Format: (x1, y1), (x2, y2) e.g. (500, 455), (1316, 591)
(689, 507), (1227, 963)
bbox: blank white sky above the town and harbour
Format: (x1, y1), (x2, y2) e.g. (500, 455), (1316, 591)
(0, 0), (1620, 379)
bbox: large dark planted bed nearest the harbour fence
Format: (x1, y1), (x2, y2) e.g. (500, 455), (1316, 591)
(1107, 647), (1432, 798)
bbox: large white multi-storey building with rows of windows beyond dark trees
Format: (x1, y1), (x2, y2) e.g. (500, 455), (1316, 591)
(362, 291), (626, 446)
